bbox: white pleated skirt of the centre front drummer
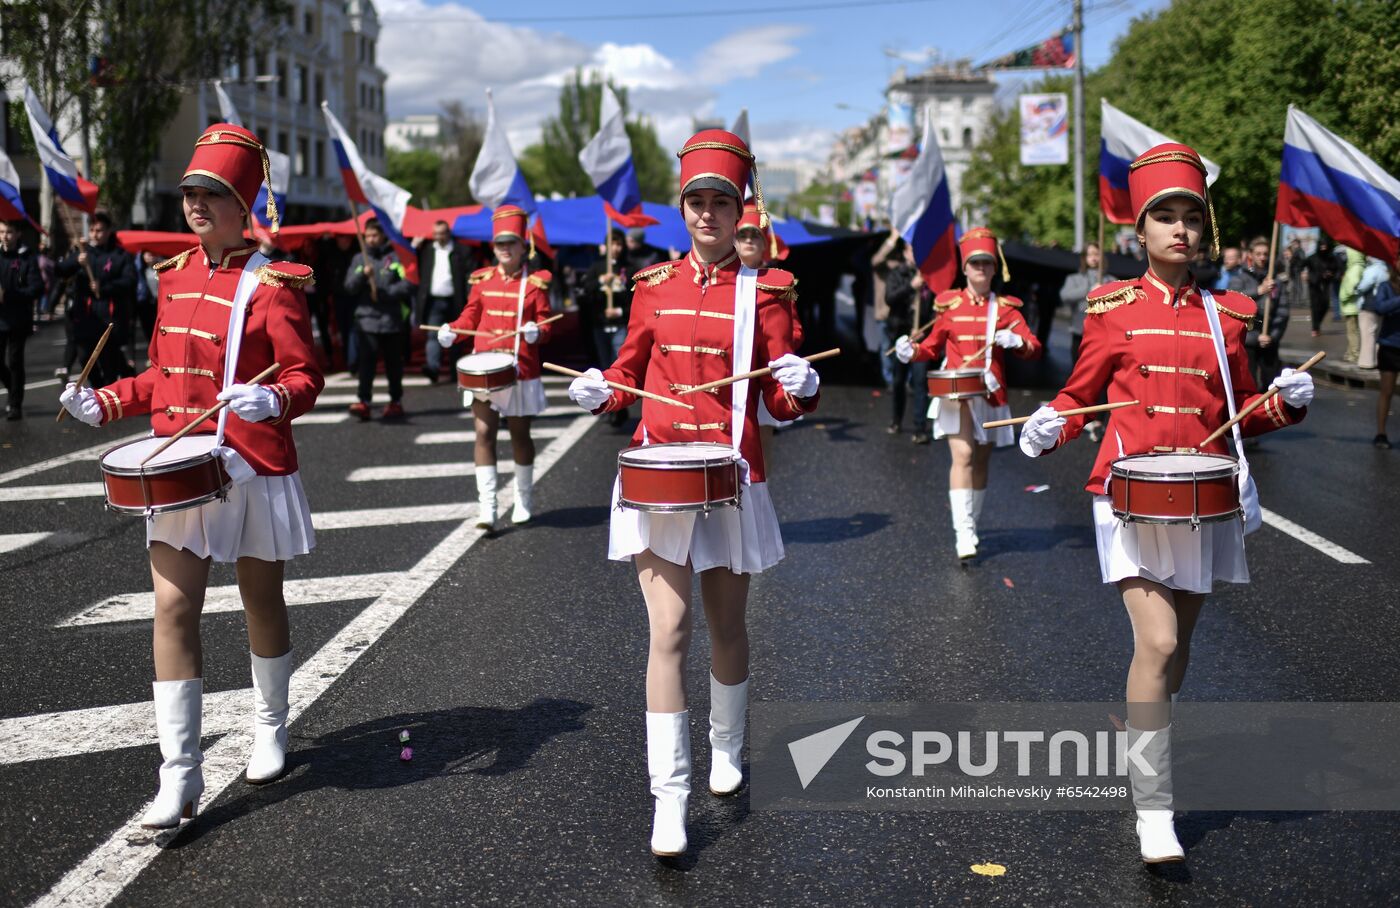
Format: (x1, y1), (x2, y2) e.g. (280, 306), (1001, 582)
(608, 480), (783, 574)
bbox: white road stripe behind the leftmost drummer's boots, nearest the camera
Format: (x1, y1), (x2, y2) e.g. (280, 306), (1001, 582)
(0, 687), (253, 765)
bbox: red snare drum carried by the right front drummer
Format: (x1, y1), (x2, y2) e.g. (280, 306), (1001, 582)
(1109, 453), (1240, 526)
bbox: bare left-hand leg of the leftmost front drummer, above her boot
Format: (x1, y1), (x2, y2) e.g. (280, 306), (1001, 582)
(150, 543), (209, 681)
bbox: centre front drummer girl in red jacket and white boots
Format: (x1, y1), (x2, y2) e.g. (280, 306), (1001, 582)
(568, 130), (819, 856)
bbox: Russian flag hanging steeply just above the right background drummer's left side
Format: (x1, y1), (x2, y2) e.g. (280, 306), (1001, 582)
(890, 111), (958, 292)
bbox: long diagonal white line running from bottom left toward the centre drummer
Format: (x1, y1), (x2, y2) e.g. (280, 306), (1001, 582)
(34, 417), (596, 907)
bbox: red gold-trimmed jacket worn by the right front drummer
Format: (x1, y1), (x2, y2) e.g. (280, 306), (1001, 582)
(1050, 271), (1306, 495)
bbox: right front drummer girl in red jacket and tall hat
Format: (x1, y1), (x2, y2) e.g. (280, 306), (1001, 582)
(1021, 144), (1313, 863)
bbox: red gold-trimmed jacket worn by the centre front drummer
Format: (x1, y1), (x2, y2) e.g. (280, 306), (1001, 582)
(596, 252), (820, 483)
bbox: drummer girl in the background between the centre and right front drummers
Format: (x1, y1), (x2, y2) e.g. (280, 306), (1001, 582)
(895, 227), (1042, 558)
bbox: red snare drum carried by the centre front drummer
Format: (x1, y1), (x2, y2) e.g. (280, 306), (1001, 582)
(617, 442), (741, 513)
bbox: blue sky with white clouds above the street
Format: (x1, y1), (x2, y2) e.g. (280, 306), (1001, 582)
(375, 0), (1166, 161)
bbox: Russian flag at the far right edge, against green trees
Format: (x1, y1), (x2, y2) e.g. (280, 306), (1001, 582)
(1274, 105), (1400, 262)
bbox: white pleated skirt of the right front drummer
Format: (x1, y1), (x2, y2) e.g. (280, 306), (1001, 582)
(1093, 495), (1249, 593)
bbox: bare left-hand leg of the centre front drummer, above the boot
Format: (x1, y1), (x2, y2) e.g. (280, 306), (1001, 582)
(634, 548), (693, 712)
